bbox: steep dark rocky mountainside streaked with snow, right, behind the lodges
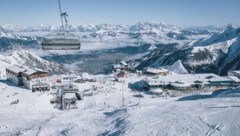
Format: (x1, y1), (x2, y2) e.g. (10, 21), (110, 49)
(130, 26), (240, 75)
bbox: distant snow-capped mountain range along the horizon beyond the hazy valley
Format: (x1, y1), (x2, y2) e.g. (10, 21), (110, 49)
(0, 22), (220, 43)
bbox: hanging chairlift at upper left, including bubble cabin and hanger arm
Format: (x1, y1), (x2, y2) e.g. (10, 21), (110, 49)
(41, 0), (81, 50)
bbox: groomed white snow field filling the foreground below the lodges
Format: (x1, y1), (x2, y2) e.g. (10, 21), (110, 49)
(0, 74), (240, 136)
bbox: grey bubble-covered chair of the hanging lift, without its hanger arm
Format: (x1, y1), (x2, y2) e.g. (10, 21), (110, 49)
(42, 32), (81, 50)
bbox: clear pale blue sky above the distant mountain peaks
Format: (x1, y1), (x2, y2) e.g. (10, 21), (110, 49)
(0, 0), (240, 26)
